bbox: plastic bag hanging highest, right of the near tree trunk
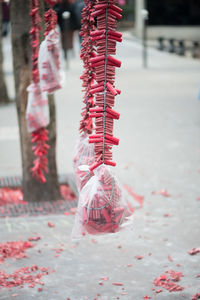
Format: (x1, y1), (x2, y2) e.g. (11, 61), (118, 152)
(38, 29), (64, 94)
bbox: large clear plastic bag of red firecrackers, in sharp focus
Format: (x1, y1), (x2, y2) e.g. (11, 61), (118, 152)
(72, 165), (131, 239)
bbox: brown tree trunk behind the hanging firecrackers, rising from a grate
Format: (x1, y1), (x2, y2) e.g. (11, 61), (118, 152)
(11, 0), (61, 201)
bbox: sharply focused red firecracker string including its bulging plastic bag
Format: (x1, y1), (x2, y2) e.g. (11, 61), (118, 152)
(72, 0), (131, 238)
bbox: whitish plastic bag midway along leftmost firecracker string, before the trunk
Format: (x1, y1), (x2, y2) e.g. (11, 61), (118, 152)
(26, 83), (49, 132)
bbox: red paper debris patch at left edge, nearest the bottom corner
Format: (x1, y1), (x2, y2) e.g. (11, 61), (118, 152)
(0, 265), (49, 289)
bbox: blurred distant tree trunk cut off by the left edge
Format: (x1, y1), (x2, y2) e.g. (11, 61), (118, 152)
(0, 1), (9, 104)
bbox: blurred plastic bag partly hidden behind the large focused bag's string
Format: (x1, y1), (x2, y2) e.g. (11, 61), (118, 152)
(73, 133), (94, 191)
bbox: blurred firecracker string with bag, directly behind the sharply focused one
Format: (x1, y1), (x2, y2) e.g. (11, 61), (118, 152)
(73, 0), (95, 190)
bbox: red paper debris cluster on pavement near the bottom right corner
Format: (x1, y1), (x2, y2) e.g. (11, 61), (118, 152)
(154, 270), (184, 292)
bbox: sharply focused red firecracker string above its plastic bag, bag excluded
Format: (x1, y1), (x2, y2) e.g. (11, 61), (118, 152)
(89, 0), (122, 171)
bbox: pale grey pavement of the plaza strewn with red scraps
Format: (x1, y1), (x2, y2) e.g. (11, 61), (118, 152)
(0, 33), (200, 300)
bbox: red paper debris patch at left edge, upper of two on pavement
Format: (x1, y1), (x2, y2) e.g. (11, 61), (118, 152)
(0, 241), (34, 264)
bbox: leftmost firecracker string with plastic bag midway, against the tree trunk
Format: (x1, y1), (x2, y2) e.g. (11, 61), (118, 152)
(26, 0), (49, 182)
